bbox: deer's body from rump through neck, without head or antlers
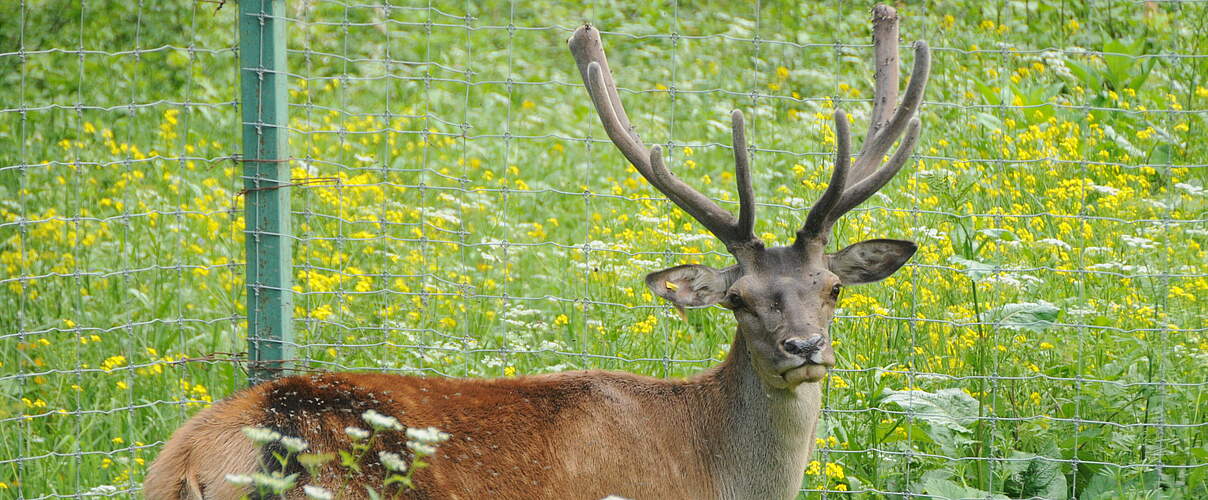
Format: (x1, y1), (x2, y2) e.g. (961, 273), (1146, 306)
(145, 330), (821, 500)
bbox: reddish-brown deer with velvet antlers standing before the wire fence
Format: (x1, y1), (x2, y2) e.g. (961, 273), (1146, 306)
(144, 6), (930, 500)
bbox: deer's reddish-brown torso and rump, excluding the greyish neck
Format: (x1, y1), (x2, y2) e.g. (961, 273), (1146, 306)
(145, 372), (714, 499)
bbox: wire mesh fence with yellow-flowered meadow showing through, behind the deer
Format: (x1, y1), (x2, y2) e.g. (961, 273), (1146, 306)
(0, 0), (1208, 499)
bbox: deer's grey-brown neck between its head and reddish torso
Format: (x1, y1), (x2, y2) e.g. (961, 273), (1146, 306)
(704, 330), (821, 499)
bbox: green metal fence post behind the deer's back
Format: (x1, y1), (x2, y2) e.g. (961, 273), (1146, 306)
(239, 0), (295, 384)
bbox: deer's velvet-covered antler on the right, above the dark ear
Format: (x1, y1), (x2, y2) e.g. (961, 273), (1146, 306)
(794, 5), (931, 249)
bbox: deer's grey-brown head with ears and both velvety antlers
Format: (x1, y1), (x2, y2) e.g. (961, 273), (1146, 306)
(569, 6), (930, 389)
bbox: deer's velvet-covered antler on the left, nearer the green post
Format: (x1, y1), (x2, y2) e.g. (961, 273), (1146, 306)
(569, 24), (754, 248)
